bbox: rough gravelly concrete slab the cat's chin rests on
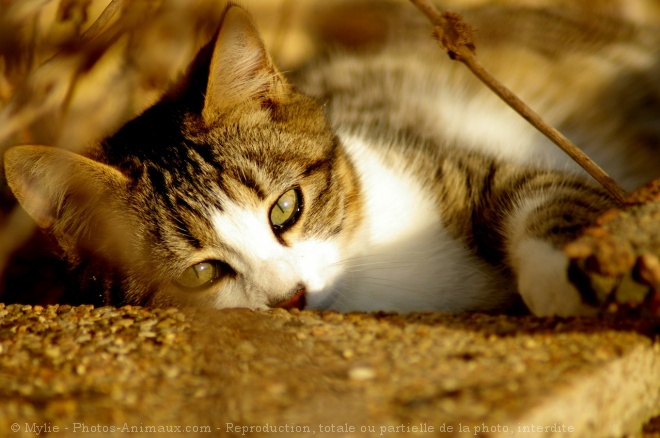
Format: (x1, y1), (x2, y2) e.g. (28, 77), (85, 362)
(0, 305), (660, 437)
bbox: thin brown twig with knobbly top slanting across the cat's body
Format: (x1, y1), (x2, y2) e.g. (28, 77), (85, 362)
(410, 0), (628, 205)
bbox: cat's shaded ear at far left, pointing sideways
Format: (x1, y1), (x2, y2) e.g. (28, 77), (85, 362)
(4, 146), (132, 266)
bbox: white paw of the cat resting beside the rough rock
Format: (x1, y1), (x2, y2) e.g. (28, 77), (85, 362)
(513, 239), (597, 316)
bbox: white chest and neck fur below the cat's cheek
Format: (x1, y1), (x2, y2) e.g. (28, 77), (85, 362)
(309, 137), (510, 312)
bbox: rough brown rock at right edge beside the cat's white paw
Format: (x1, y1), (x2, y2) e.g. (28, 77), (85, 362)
(564, 186), (660, 317)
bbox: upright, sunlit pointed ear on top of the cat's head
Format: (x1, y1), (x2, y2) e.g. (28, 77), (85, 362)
(202, 5), (289, 122)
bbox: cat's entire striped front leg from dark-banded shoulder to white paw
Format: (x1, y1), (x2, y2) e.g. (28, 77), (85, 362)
(436, 152), (616, 316)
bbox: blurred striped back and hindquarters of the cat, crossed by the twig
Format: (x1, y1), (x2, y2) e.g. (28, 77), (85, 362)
(298, 5), (660, 187)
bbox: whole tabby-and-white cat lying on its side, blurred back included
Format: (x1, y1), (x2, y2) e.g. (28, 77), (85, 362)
(4, 0), (660, 315)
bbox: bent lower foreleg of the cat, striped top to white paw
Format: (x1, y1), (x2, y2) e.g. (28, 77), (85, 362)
(505, 173), (612, 316)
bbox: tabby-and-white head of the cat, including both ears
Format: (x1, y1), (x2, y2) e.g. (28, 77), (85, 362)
(5, 6), (361, 308)
